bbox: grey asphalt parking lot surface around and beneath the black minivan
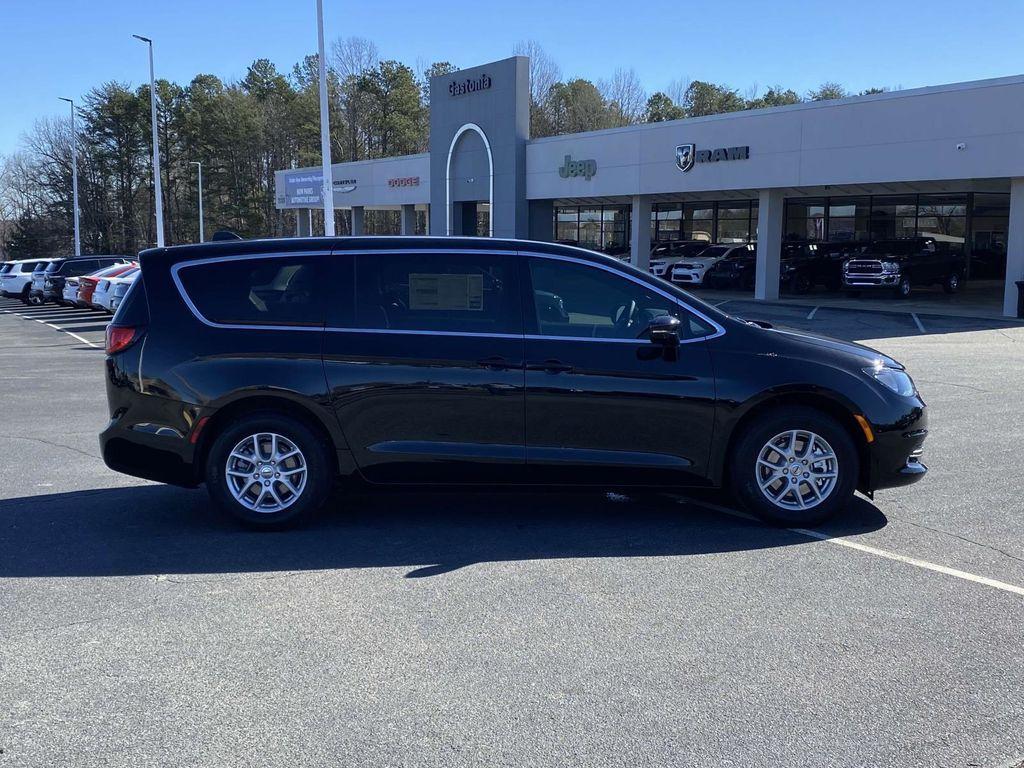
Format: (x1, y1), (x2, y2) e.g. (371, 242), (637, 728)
(0, 299), (1024, 768)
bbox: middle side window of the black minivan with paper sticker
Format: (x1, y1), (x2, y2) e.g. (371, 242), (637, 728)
(355, 252), (522, 334)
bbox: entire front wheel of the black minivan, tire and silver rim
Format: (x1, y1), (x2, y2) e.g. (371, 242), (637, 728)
(731, 407), (860, 525)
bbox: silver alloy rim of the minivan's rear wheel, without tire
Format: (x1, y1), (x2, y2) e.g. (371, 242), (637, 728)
(224, 432), (308, 514)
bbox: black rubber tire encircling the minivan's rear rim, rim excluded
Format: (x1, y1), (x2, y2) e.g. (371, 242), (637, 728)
(205, 411), (335, 530)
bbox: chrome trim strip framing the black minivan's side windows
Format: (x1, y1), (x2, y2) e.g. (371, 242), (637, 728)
(171, 247), (725, 344)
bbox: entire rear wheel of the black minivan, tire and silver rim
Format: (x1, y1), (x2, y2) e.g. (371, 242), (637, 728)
(205, 412), (334, 529)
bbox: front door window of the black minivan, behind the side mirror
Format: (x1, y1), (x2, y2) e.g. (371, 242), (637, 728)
(529, 258), (713, 339)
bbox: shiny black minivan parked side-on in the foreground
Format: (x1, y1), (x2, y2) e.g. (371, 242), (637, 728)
(100, 238), (927, 527)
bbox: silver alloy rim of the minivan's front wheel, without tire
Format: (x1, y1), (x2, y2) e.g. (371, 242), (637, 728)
(754, 429), (839, 510)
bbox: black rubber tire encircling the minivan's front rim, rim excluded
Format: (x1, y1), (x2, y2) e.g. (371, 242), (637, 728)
(729, 406), (860, 526)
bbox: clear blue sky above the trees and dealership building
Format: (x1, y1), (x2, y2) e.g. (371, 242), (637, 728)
(0, 0), (1024, 154)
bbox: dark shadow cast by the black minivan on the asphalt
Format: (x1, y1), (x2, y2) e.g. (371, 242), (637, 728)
(0, 485), (887, 578)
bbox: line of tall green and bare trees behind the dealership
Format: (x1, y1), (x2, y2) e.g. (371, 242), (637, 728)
(0, 38), (892, 258)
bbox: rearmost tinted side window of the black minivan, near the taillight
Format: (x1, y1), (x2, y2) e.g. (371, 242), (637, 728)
(177, 256), (325, 326)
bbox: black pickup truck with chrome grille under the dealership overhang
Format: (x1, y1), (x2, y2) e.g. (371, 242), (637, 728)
(843, 238), (967, 298)
